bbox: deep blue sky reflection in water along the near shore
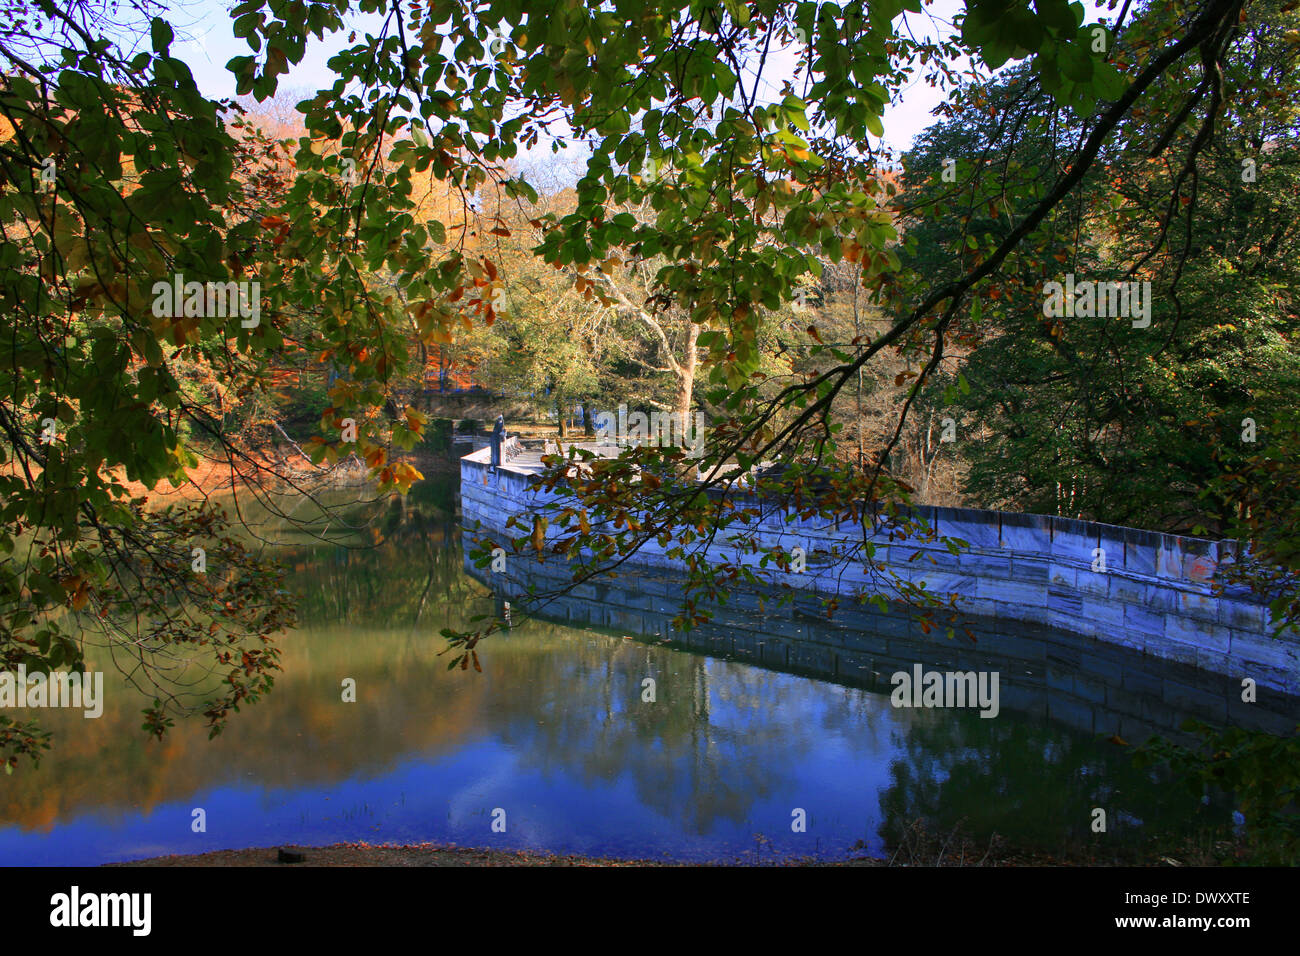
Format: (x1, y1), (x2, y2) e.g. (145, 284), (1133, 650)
(0, 658), (901, 865)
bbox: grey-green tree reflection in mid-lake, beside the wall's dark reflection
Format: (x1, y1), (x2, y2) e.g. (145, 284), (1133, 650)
(483, 622), (878, 834)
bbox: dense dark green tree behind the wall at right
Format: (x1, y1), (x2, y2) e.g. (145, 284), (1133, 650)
(909, 7), (1300, 532)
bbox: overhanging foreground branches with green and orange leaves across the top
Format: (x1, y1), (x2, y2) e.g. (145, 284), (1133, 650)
(0, 0), (1284, 770)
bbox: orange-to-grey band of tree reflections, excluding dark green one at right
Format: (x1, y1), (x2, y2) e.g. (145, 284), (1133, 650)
(10, 546), (878, 832)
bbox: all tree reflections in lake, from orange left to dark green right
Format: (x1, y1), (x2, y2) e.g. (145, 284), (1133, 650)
(0, 494), (1216, 853)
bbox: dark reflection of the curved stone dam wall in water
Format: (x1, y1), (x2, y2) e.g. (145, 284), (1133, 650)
(462, 531), (1300, 743)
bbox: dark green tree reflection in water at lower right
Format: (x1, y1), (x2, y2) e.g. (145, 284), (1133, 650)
(880, 710), (1201, 847)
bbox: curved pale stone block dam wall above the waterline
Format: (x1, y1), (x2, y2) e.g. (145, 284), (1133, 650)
(460, 449), (1300, 695)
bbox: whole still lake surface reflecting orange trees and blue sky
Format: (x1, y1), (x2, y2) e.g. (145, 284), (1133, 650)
(0, 488), (1279, 865)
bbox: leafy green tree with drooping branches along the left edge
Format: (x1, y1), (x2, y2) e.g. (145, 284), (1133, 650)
(0, 1), (309, 771)
